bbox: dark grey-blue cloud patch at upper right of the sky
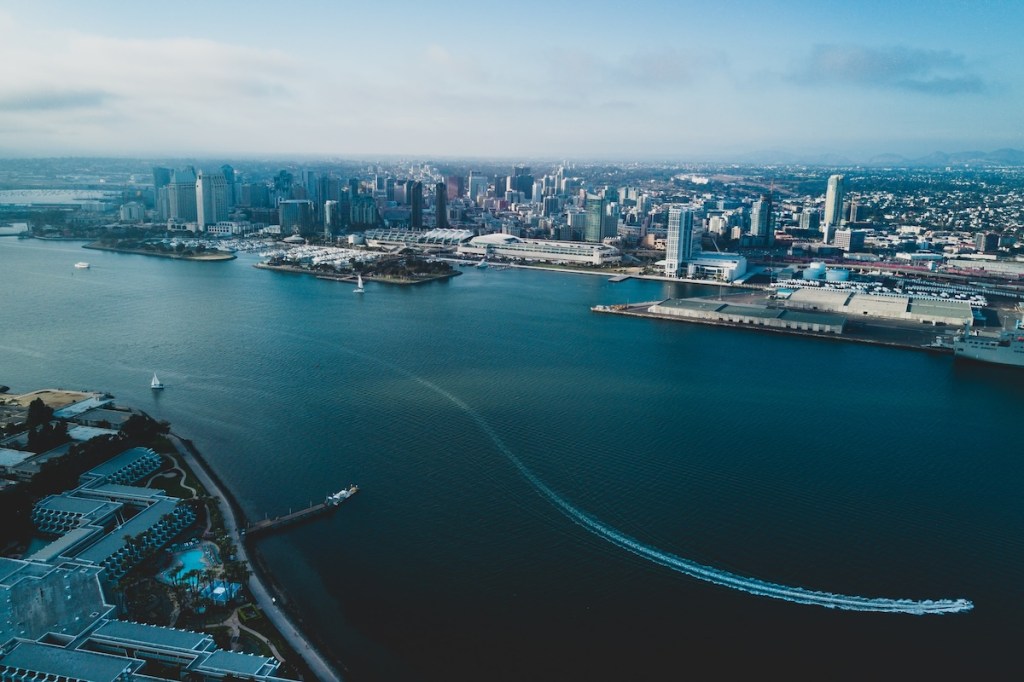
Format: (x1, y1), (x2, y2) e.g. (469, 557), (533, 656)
(788, 45), (989, 95)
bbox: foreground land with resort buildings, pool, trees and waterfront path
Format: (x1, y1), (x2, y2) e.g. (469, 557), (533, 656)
(0, 389), (346, 682)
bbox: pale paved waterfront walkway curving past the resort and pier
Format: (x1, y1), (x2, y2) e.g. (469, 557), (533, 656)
(168, 433), (342, 682)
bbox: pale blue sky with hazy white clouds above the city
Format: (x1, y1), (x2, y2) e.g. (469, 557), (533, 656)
(0, 0), (1024, 162)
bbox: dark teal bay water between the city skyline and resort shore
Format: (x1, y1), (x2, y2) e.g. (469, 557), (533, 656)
(0, 238), (1024, 681)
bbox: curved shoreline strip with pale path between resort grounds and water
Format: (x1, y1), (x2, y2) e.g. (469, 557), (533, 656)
(168, 432), (343, 682)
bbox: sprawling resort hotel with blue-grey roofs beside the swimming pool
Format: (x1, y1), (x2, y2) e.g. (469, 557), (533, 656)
(0, 395), (281, 682)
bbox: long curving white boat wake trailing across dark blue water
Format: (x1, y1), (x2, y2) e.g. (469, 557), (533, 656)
(356, 358), (974, 615)
